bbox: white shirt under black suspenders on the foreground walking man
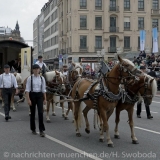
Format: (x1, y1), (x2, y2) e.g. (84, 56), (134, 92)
(25, 75), (46, 93)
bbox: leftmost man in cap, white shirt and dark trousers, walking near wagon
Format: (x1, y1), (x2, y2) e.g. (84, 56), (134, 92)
(0, 64), (18, 121)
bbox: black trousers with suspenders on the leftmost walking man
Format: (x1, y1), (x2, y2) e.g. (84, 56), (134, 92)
(2, 74), (13, 117)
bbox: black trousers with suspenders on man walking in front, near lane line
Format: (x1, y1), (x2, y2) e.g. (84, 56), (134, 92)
(29, 76), (45, 132)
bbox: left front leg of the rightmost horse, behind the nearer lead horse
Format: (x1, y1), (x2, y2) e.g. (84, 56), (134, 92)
(114, 107), (121, 139)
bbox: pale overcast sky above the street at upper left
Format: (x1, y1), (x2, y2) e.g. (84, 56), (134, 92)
(0, 0), (48, 44)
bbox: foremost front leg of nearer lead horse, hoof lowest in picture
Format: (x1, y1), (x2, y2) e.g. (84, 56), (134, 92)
(100, 109), (114, 147)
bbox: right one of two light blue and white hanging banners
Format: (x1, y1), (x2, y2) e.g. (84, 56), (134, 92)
(152, 28), (158, 53)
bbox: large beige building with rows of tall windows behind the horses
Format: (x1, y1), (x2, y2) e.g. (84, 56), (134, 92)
(58, 0), (160, 63)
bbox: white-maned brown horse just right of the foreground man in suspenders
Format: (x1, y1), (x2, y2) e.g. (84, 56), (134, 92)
(44, 71), (66, 122)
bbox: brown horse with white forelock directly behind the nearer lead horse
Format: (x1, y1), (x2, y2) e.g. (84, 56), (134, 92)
(60, 62), (83, 121)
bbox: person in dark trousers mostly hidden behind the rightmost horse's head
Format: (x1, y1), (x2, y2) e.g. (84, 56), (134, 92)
(137, 66), (153, 119)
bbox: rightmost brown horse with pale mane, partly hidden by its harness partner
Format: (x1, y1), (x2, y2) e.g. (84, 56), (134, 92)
(114, 73), (157, 144)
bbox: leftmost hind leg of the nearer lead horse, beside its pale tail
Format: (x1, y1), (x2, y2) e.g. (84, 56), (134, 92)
(74, 102), (82, 137)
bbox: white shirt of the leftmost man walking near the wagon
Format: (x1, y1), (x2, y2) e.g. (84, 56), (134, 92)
(0, 73), (18, 88)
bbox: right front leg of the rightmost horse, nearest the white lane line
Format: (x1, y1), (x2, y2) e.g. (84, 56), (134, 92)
(127, 106), (139, 144)
